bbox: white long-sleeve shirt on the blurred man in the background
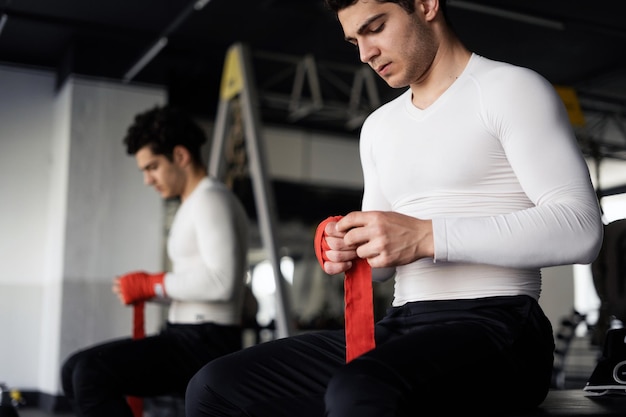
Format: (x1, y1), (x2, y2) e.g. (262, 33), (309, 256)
(165, 177), (249, 325)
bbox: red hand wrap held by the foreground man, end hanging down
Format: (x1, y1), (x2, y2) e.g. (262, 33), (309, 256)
(313, 216), (376, 363)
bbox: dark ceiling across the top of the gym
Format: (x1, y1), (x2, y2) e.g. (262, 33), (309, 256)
(0, 0), (626, 157)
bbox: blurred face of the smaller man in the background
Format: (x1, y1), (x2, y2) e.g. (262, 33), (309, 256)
(135, 146), (184, 198)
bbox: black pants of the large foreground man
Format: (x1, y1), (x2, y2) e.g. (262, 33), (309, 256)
(185, 296), (554, 417)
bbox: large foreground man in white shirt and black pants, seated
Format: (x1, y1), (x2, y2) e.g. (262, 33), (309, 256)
(186, 0), (602, 417)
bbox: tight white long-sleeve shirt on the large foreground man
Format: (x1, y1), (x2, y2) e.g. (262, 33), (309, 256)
(360, 54), (602, 306)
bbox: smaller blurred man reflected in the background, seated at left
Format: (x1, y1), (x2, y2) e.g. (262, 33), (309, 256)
(61, 106), (249, 417)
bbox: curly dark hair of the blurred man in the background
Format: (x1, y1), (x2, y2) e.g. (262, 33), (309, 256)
(124, 106), (207, 166)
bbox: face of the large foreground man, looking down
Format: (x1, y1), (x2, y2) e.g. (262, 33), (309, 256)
(337, 0), (438, 88)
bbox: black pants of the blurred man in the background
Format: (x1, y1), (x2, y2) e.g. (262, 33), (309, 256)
(61, 323), (242, 417)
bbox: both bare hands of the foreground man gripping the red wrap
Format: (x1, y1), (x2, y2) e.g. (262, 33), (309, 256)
(324, 211), (434, 275)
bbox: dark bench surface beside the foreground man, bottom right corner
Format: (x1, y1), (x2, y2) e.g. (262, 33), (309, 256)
(507, 389), (626, 417)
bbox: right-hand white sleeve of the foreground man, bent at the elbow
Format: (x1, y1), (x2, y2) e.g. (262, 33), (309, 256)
(433, 69), (602, 268)
